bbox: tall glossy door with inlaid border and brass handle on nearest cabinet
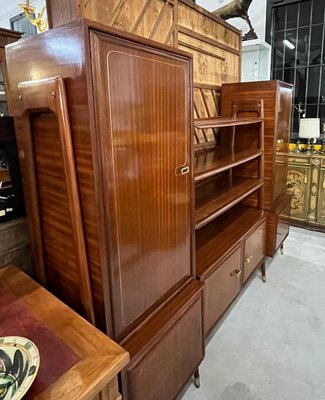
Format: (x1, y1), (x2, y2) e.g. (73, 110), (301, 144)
(90, 31), (193, 339)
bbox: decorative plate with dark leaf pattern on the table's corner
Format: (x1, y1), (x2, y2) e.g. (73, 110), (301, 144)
(0, 336), (40, 400)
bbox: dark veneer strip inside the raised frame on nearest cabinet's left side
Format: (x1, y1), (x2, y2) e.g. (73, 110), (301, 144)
(32, 113), (82, 312)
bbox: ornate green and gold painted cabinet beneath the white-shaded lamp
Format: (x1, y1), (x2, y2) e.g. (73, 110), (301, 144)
(287, 153), (325, 231)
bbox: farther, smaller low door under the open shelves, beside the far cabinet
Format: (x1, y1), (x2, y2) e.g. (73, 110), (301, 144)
(244, 222), (266, 281)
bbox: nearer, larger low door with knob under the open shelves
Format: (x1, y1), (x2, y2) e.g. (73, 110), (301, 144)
(204, 247), (241, 334)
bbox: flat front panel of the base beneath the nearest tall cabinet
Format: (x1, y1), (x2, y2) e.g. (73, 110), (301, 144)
(122, 286), (204, 400)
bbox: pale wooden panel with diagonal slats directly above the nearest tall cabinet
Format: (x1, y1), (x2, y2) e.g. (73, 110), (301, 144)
(83, 0), (174, 46)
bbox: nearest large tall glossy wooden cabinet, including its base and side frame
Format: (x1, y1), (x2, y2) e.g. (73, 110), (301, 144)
(7, 20), (204, 400)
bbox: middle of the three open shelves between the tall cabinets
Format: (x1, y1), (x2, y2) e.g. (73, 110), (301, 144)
(194, 147), (263, 182)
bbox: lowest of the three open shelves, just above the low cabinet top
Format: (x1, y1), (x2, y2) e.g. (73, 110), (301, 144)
(195, 176), (263, 229)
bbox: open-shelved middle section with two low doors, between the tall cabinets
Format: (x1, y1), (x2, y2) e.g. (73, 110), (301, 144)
(194, 100), (265, 335)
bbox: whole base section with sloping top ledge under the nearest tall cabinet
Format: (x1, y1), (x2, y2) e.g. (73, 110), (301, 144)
(121, 281), (204, 400)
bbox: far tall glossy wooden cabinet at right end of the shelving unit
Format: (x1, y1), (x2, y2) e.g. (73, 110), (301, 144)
(221, 80), (292, 257)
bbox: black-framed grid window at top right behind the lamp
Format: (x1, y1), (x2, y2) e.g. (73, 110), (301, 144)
(271, 0), (325, 138)
